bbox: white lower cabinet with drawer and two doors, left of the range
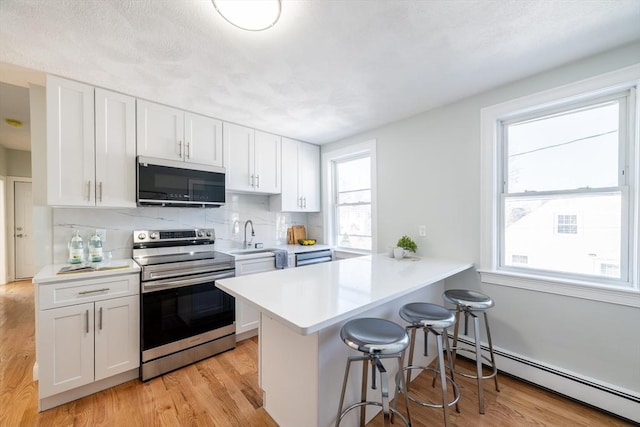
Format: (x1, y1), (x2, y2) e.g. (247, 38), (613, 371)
(36, 274), (140, 410)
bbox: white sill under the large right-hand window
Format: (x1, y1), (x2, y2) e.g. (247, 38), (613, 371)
(479, 270), (640, 307)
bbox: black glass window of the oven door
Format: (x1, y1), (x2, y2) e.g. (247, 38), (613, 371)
(142, 282), (235, 350)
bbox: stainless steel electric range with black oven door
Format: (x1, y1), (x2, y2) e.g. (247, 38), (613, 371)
(133, 229), (236, 381)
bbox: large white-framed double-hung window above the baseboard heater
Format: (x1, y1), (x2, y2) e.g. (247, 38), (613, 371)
(480, 66), (640, 306)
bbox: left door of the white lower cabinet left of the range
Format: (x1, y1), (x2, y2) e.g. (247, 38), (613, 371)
(37, 303), (94, 399)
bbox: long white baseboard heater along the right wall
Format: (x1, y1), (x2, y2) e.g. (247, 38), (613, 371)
(458, 335), (640, 423)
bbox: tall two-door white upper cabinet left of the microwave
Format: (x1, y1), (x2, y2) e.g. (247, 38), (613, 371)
(46, 76), (136, 207)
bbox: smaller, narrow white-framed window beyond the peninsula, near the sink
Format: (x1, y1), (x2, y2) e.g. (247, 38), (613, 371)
(322, 141), (376, 252)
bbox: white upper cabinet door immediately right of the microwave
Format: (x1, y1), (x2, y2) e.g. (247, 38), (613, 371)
(223, 123), (255, 191)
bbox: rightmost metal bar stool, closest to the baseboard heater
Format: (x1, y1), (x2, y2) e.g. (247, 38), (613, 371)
(442, 289), (500, 414)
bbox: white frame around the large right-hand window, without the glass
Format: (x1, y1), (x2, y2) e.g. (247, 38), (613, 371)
(479, 64), (640, 307)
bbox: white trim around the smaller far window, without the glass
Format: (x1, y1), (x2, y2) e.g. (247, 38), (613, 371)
(322, 139), (378, 254)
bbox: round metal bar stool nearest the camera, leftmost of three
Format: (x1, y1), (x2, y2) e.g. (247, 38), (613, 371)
(336, 318), (411, 427)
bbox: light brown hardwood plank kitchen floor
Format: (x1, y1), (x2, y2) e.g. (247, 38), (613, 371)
(0, 281), (630, 427)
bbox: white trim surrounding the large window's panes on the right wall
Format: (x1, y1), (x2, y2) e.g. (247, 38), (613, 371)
(479, 64), (640, 307)
